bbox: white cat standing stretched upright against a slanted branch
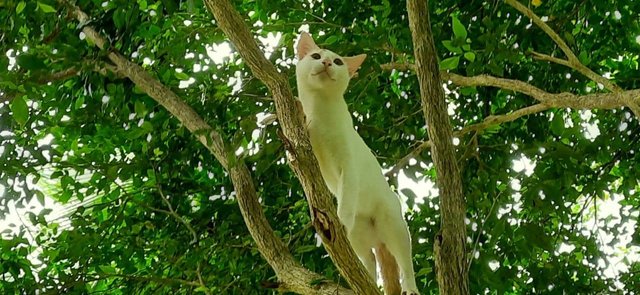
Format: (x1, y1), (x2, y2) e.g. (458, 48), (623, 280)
(296, 33), (419, 295)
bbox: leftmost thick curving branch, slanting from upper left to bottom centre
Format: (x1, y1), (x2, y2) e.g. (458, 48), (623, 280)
(58, 0), (352, 295)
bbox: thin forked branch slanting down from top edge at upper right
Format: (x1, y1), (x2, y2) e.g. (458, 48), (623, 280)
(505, 0), (622, 92)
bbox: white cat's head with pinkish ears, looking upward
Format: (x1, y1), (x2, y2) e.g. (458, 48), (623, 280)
(296, 32), (367, 94)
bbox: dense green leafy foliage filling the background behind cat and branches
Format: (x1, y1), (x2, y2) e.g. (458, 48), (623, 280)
(0, 0), (640, 294)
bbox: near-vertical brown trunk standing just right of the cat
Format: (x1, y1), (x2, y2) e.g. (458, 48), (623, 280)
(407, 0), (469, 295)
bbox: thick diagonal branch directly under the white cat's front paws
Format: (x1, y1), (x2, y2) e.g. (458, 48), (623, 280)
(204, 0), (380, 294)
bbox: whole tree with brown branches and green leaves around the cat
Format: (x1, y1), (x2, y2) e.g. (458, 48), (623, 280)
(0, 0), (640, 294)
